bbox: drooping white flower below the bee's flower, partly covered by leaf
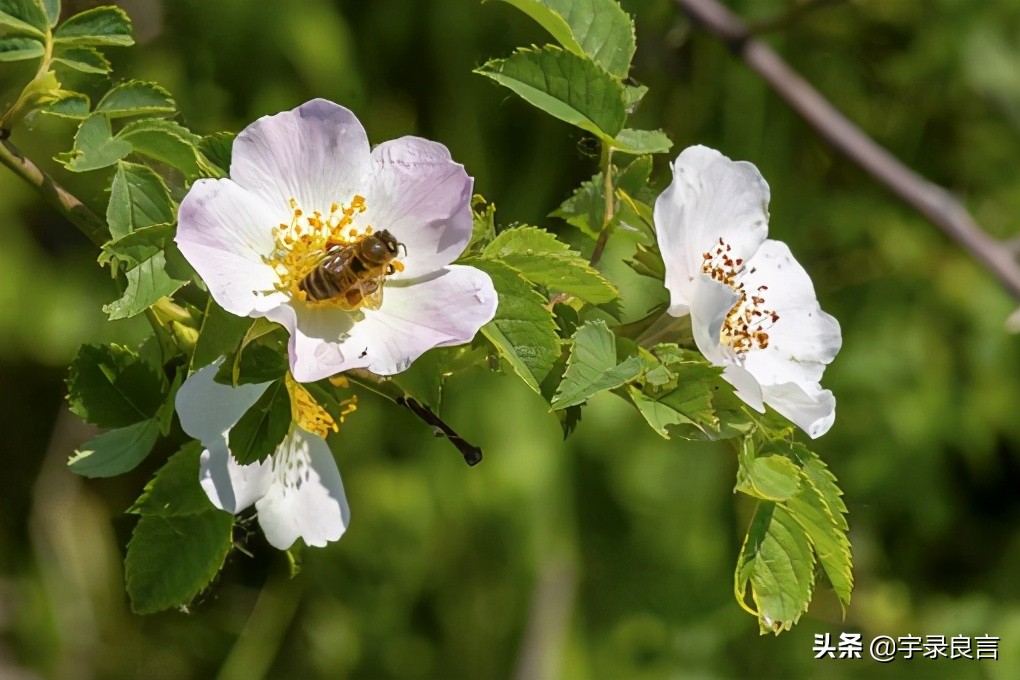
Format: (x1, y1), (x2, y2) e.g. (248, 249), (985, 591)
(175, 359), (351, 550)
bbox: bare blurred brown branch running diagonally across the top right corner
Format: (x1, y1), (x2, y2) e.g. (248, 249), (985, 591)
(674, 0), (1020, 299)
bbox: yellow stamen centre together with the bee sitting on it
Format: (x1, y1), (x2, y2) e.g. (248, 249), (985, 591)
(265, 195), (404, 311)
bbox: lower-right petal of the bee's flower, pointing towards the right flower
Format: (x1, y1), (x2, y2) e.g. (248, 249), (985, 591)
(354, 265), (498, 375)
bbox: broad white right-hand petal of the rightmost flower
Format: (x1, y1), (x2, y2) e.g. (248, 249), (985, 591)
(741, 240), (843, 385)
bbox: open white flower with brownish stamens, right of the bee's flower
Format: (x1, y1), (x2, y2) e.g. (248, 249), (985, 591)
(655, 146), (843, 437)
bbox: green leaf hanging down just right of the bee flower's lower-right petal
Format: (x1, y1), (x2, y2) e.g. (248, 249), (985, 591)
(464, 258), (560, 395)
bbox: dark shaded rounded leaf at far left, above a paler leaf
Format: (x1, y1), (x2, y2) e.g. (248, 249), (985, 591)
(67, 345), (166, 427)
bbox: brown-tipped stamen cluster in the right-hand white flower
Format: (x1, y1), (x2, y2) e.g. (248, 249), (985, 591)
(702, 239), (779, 356)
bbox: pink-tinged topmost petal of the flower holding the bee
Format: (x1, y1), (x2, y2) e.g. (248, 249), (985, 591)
(231, 99), (369, 213)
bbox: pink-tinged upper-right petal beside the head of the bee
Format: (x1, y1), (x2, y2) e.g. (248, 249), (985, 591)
(359, 137), (474, 280)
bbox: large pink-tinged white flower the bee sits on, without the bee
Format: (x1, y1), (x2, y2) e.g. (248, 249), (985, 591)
(176, 99), (497, 382)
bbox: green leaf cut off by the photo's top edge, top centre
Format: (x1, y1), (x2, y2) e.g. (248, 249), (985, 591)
(495, 0), (635, 79)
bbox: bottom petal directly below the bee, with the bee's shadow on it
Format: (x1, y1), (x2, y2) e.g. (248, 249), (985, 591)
(266, 302), (369, 382)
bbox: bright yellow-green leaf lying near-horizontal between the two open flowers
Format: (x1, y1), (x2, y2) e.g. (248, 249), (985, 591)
(481, 226), (620, 305)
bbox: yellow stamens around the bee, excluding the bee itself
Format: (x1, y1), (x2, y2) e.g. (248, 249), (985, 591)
(266, 196), (381, 301)
